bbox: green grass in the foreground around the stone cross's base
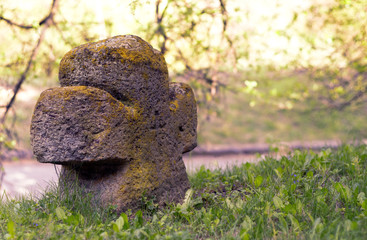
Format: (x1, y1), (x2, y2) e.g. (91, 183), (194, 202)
(0, 145), (367, 239)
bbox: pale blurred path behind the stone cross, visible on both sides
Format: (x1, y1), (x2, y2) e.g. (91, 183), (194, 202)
(0, 140), (367, 198)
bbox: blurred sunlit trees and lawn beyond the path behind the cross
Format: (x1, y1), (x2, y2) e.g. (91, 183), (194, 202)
(0, 0), (367, 159)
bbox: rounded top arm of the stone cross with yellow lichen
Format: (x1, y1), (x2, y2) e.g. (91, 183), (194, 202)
(59, 35), (168, 127)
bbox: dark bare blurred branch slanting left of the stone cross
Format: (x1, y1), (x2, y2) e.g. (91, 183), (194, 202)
(0, 0), (59, 124)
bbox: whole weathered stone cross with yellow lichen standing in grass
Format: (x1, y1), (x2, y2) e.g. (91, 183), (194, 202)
(31, 35), (197, 211)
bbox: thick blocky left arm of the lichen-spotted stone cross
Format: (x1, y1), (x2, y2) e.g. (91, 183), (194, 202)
(31, 86), (139, 164)
